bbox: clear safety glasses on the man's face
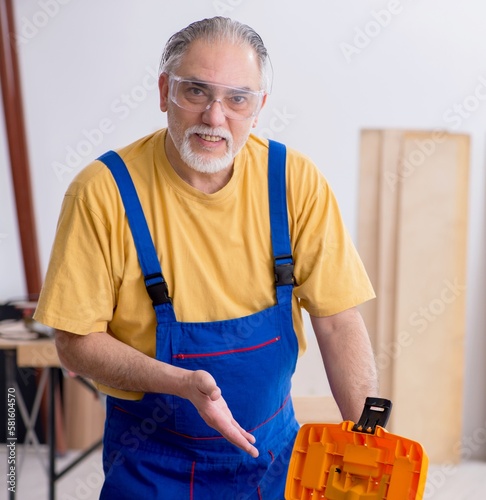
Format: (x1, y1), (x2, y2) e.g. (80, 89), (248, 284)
(169, 74), (265, 120)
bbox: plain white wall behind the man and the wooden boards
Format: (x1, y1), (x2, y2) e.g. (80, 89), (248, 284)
(0, 0), (486, 458)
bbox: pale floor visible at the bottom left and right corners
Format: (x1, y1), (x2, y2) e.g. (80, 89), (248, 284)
(0, 449), (486, 500)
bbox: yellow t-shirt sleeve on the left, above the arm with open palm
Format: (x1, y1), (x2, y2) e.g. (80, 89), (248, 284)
(35, 170), (116, 335)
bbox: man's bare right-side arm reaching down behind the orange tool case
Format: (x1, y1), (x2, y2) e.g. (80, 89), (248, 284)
(311, 307), (378, 423)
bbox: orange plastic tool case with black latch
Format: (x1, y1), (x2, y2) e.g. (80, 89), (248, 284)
(285, 398), (428, 500)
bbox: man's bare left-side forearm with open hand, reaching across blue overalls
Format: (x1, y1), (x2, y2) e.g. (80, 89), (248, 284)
(56, 330), (258, 457)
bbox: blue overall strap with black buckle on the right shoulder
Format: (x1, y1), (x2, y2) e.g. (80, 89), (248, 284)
(268, 140), (294, 292)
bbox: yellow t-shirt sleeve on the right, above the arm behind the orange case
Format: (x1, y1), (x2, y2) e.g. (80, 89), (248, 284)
(289, 154), (375, 316)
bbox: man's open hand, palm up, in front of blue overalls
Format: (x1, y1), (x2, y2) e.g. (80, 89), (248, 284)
(186, 370), (258, 458)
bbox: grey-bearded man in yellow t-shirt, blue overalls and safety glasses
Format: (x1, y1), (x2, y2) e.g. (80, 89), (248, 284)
(36, 17), (377, 500)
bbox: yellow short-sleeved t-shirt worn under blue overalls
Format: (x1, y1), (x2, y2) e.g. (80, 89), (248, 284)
(35, 130), (374, 399)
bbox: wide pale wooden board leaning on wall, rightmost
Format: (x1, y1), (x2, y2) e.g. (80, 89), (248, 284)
(393, 133), (469, 463)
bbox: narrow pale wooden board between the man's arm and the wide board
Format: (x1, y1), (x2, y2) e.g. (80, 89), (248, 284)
(358, 130), (402, 399)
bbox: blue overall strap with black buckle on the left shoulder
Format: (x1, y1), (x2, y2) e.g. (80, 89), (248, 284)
(98, 151), (171, 306)
